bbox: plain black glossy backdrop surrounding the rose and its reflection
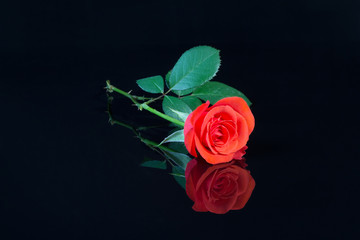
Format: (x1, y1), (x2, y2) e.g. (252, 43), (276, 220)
(0, 0), (360, 239)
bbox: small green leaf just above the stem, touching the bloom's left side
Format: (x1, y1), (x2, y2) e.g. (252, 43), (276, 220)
(162, 96), (192, 122)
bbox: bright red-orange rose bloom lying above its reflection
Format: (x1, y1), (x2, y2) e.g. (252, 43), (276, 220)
(184, 97), (255, 164)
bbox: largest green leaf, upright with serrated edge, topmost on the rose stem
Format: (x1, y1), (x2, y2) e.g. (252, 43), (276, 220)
(169, 46), (220, 90)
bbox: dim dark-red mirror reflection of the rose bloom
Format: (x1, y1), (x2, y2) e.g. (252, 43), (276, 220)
(185, 159), (255, 214)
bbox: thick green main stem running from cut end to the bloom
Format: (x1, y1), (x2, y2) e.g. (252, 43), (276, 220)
(106, 80), (185, 127)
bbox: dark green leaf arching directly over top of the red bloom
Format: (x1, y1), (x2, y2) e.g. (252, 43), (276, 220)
(191, 82), (251, 106)
